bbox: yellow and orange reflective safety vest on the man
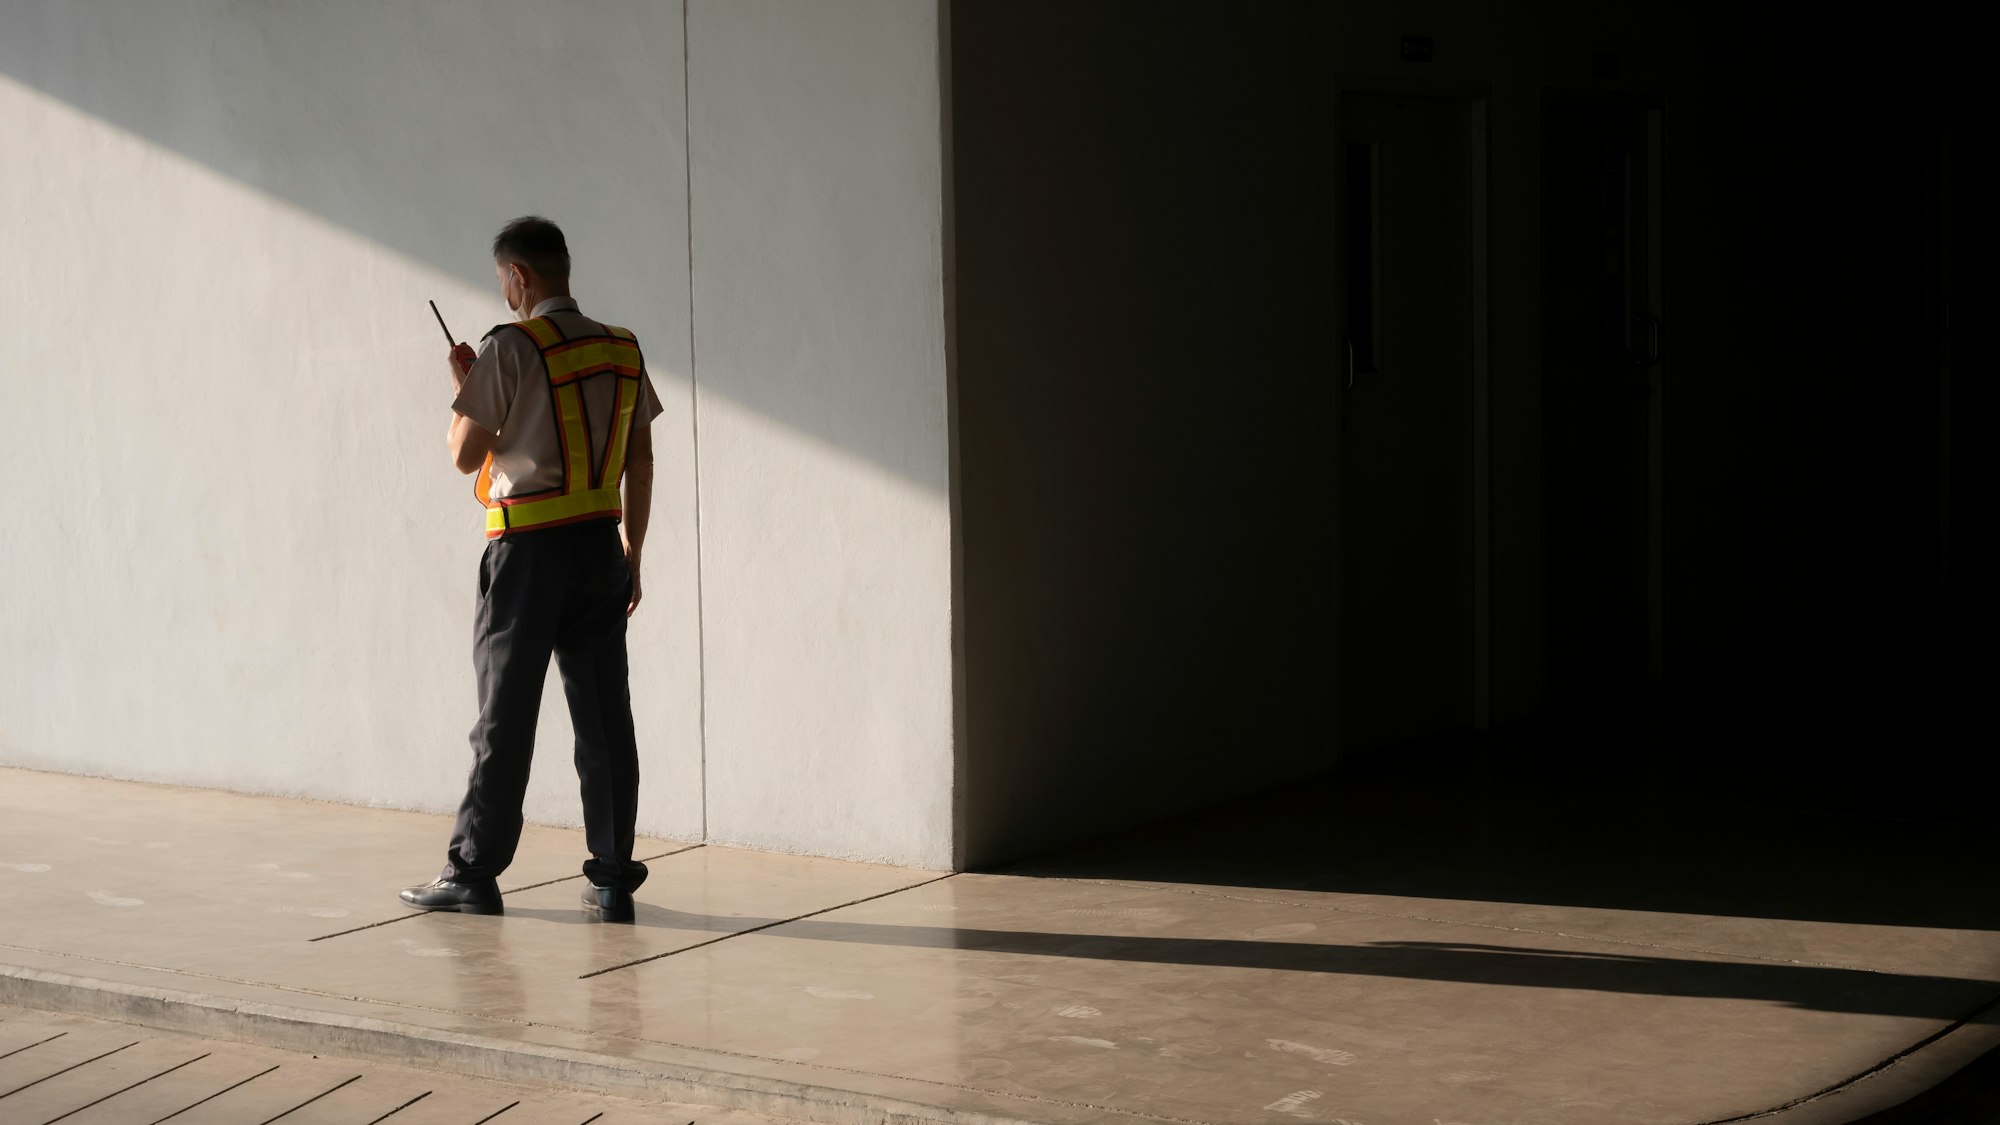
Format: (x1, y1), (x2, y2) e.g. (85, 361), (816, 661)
(472, 316), (644, 538)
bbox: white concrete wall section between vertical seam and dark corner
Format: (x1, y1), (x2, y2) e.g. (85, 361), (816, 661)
(688, 0), (952, 867)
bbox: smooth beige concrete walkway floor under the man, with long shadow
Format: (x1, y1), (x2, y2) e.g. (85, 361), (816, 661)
(0, 756), (2000, 1125)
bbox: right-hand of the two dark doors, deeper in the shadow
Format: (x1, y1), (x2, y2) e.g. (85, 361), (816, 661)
(1542, 92), (1662, 731)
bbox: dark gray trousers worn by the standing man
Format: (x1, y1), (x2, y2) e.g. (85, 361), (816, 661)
(442, 518), (646, 891)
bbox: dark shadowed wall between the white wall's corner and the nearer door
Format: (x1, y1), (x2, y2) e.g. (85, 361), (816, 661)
(952, 4), (1336, 857)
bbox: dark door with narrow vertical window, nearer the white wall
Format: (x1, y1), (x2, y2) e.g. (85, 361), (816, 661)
(1338, 92), (1484, 759)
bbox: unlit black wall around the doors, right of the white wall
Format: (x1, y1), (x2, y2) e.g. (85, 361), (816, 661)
(950, 2), (2000, 868)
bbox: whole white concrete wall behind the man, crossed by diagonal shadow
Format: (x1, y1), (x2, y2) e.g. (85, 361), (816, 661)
(0, 0), (950, 875)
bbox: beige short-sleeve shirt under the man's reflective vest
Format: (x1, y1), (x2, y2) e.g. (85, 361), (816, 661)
(452, 296), (662, 500)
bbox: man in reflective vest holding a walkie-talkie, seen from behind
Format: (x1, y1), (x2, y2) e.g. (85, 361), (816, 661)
(402, 216), (660, 921)
